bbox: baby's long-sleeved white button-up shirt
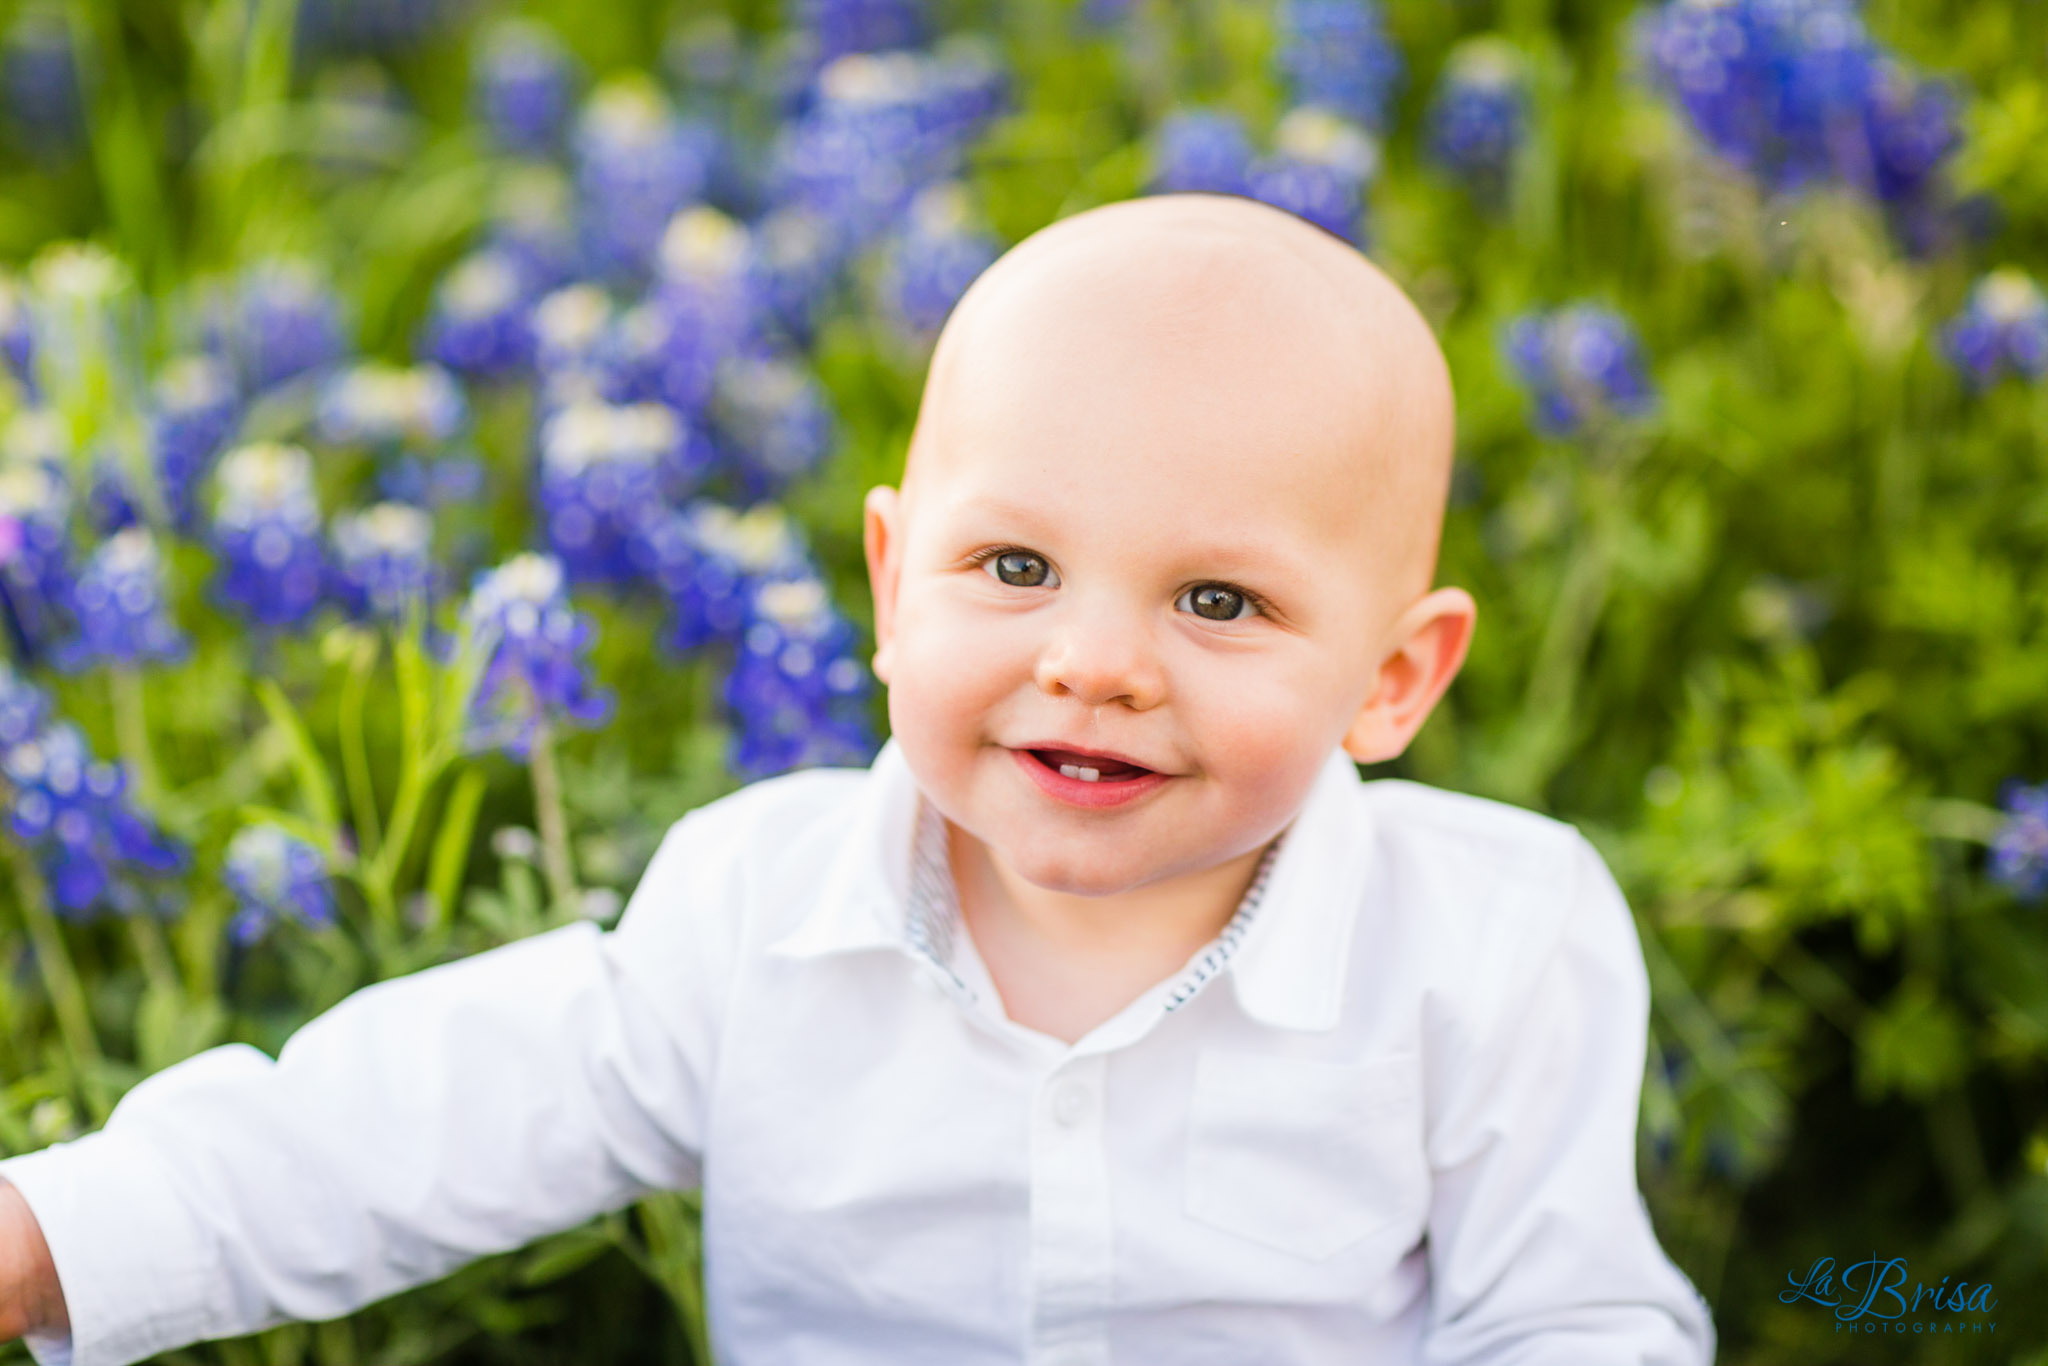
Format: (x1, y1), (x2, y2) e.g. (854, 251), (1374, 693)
(0, 743), (1714, 1366)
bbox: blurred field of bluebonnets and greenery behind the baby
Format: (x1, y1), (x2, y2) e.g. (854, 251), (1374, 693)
(0, 0), (2048, 1366)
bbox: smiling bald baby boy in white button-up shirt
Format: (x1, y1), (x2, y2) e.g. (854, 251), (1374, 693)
(0, 195), (1714, 1366)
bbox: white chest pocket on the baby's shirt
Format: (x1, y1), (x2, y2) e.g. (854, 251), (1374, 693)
(1184, 1051), (1430, 1262)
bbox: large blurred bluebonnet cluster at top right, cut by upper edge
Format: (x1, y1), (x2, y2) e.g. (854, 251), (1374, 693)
(1638, 0), (1960, 219)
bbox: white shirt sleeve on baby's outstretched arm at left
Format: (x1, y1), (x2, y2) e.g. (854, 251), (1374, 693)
(0, 817), (737, 1366)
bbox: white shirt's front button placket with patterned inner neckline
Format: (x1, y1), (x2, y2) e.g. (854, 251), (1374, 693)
(905, 799), (1280, 1366)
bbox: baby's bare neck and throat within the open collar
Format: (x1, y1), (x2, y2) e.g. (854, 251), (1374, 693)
(946, 821), (1266, 1044)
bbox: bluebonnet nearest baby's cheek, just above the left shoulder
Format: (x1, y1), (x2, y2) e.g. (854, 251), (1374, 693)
(725, 578), (874, 778)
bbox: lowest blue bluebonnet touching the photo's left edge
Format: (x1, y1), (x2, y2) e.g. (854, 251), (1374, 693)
(0, 721), (186, 920)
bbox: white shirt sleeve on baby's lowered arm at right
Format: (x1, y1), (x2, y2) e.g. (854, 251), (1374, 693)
(1421, 834), (1714, 1366)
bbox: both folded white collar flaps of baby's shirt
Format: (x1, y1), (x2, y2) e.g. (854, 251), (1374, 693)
(768, 739), (1370, 1030)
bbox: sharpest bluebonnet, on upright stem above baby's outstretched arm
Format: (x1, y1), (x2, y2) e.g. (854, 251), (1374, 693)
(463, 553), (612, 760)
